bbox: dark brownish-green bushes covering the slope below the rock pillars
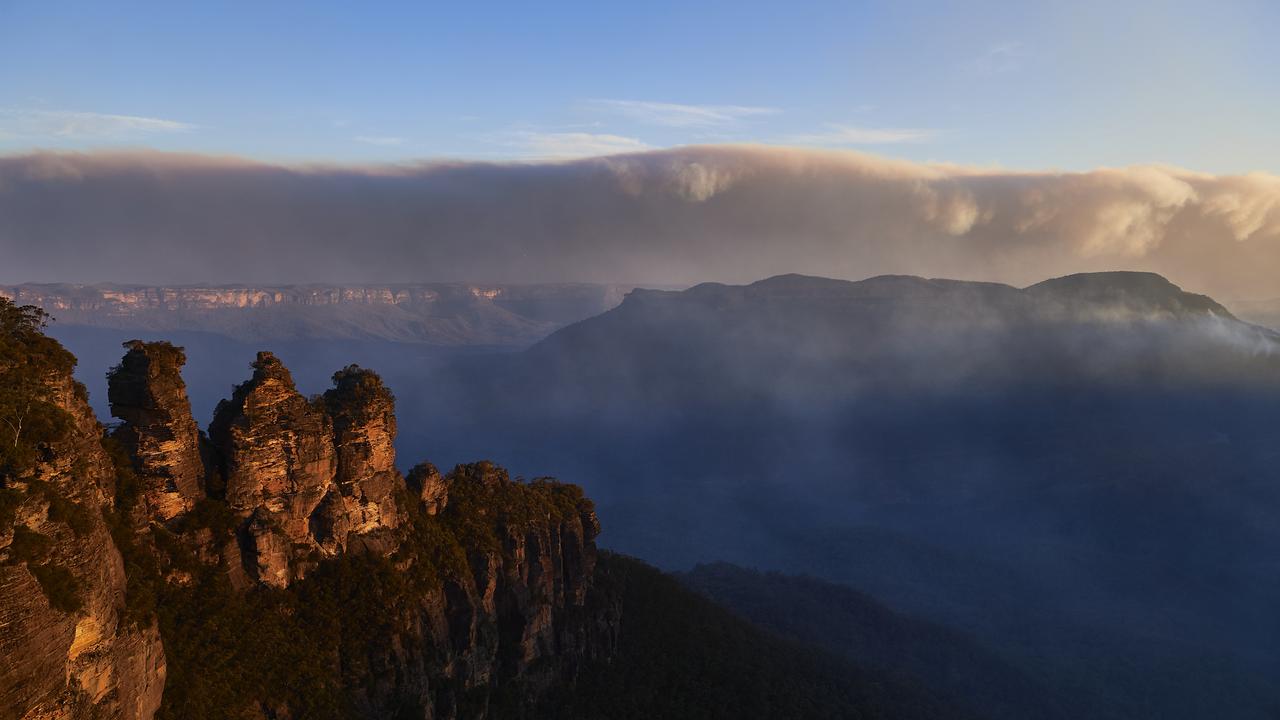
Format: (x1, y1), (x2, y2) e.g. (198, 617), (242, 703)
(141, 462), (589, 720)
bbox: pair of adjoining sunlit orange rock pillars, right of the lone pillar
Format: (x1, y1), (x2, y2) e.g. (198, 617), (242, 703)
(210, 352), (404, 587)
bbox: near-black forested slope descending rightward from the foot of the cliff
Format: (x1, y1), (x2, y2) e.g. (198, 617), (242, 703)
(550, 553), (966, 720)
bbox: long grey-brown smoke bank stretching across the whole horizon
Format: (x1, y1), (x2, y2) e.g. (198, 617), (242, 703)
(0, 146), (1280, 299)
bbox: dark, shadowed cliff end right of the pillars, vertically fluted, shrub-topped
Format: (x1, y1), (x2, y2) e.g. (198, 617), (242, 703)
(325, 462), (616, 717)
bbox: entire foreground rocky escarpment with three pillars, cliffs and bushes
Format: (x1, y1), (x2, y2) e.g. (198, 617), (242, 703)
(0, 304), (618, 719)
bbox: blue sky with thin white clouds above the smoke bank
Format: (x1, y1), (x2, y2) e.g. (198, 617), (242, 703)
(0, 0), (1280, 173)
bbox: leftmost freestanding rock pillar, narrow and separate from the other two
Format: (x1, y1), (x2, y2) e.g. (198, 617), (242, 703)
(108, 341), (205, 521)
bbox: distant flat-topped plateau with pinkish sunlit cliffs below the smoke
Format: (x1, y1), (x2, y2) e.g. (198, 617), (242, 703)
(0, 283), (632, 347)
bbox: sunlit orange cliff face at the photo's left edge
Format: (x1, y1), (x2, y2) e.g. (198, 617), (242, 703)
(0, 343), (166, 720)
